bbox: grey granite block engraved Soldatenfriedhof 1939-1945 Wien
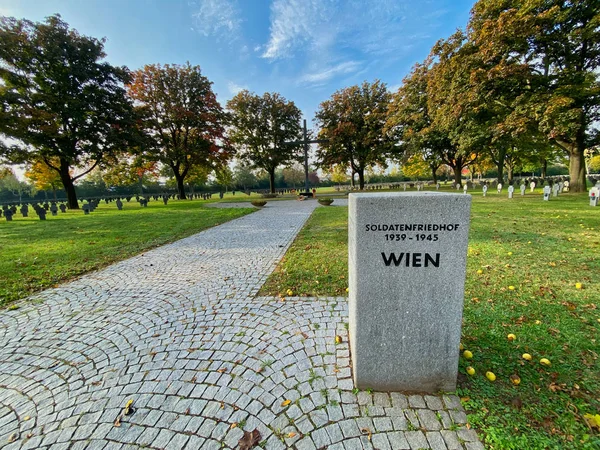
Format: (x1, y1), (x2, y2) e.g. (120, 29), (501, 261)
(348, 192), (471, 392)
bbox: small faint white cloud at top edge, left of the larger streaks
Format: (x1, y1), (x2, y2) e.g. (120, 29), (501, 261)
(190, 0), (242, 41)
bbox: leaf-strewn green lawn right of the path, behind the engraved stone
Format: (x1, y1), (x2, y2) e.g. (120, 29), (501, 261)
(261, 193), (600, 450)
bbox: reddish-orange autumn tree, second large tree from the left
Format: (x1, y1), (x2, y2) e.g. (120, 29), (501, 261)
(127, 63), (232, 199)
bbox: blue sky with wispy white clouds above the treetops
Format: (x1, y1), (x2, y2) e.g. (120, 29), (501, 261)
(0, 0), (473, 124)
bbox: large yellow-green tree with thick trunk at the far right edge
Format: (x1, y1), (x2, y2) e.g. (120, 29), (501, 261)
(469, 0), (600, 192)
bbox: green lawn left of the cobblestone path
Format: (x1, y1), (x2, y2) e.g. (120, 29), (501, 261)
(0, 201), (253, 306)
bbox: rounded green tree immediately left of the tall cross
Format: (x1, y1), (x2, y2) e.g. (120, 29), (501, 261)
(227, 90), (302, 193)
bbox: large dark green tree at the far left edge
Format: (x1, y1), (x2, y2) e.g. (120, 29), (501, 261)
(0, 15), (132, 209)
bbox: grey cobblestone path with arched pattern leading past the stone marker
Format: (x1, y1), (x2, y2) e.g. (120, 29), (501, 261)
(0, 201), (483, 450)
